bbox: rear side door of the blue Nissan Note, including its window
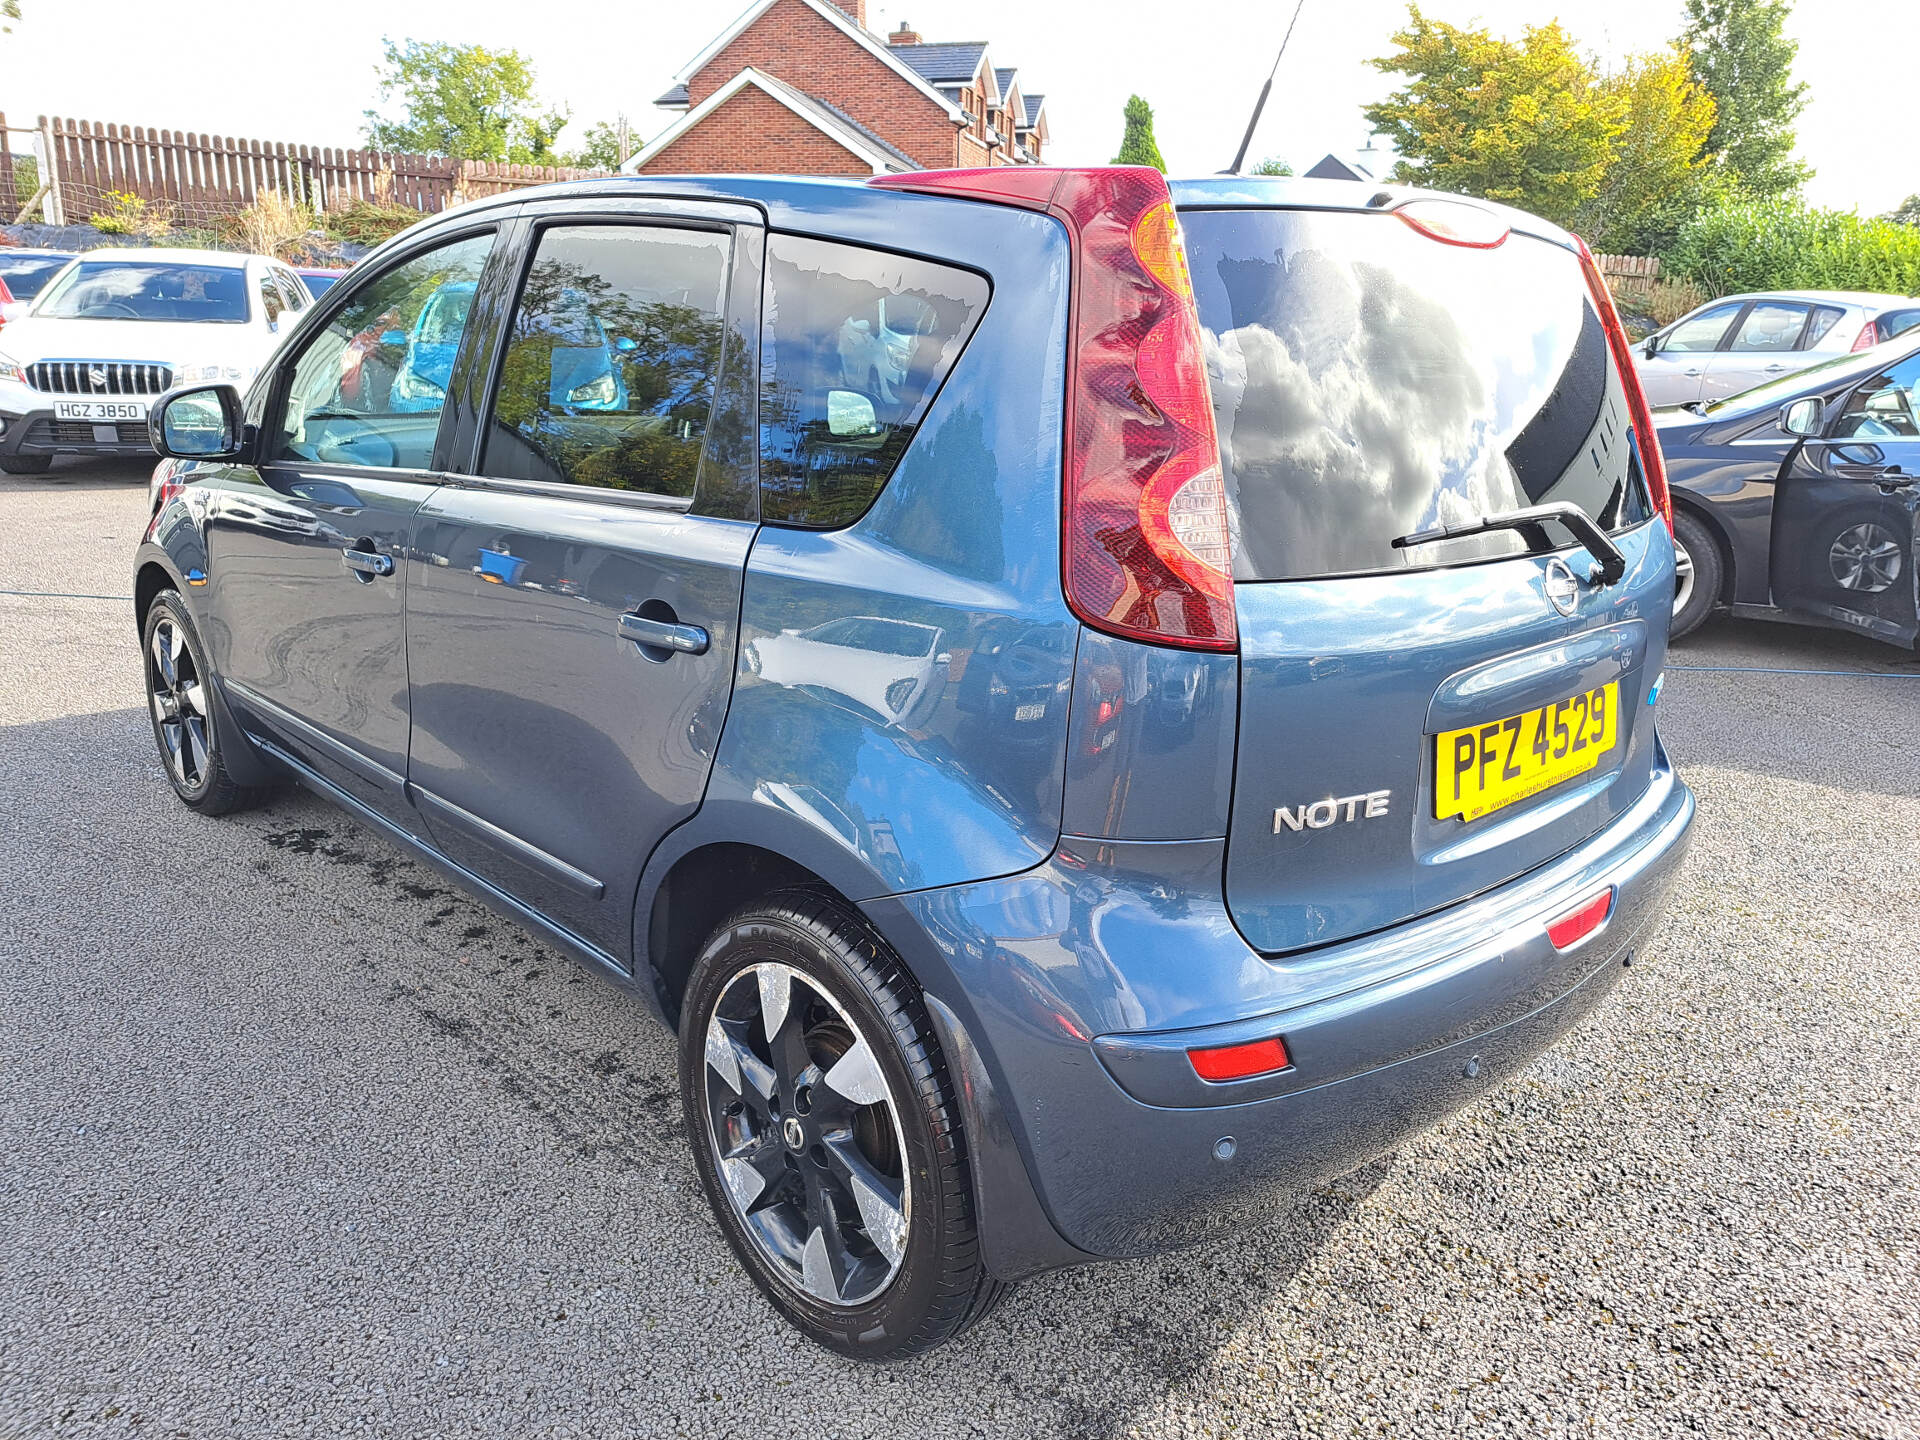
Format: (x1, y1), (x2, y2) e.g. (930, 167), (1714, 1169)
(407, 202), (762, 964)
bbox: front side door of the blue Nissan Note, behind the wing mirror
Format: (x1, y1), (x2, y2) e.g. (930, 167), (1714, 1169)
(207, 228), (493, 829)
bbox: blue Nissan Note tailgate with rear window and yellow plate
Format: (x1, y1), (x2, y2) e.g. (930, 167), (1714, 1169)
(1183, 209), (1674, 952)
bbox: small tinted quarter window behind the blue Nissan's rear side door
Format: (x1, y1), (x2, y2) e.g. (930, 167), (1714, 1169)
(760, 234), (987, 528)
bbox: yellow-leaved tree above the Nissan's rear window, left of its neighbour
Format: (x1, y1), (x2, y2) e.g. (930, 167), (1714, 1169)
(1361, 6), (1628, 225)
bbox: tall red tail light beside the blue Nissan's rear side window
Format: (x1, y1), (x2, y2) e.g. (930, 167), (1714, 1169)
(872, 165), (1238, 651)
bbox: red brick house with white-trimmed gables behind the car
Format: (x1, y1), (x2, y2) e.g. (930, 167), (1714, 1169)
(626, 0), (1046, 175)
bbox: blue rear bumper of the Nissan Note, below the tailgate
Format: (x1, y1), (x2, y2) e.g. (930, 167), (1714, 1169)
(870, 755), (1693, 1275)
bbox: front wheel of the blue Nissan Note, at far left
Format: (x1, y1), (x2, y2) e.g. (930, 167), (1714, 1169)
(140, 589), (269, 816)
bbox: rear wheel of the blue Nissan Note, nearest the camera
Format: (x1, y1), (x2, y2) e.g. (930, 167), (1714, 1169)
(680, 891), (1012, 1359)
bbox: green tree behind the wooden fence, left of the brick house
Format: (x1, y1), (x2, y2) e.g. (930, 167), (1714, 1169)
(367, 40), (568, 165)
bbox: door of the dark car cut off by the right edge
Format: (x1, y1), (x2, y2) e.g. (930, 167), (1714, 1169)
(1772, 355), (1920, 645)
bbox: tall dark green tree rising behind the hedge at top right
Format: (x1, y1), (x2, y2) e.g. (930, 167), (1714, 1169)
(1684, 0), (1812, 196)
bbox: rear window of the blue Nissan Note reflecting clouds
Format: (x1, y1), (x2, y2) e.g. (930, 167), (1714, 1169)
(1183, 209), (1651, 580)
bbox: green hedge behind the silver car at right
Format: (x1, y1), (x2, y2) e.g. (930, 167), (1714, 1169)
(1661, 200), (1920, 296)
